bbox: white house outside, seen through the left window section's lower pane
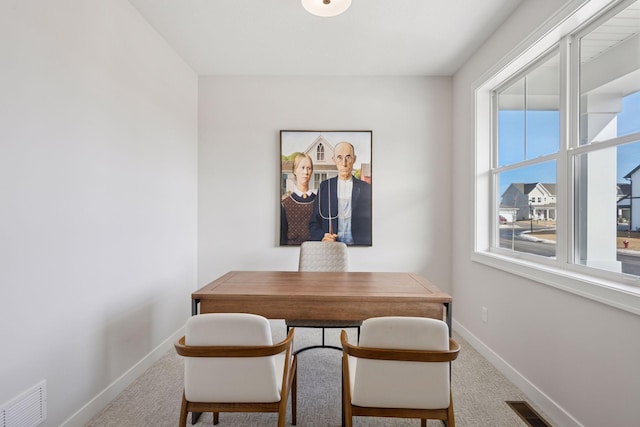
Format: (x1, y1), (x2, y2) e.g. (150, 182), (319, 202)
(500, 182), (556, 221)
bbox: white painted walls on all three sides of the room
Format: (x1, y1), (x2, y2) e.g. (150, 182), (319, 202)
(8, 0), (640, 426)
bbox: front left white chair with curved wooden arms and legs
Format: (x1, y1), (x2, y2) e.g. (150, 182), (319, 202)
(175, 313), (297, 427)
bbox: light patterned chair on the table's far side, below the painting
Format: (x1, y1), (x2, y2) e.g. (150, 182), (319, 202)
(285, 241), (362, 354)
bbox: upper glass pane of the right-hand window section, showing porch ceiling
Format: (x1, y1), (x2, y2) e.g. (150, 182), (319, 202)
(580, 1), (640, 145)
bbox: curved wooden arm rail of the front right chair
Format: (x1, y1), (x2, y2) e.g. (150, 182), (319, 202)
(340, 331), (460, 362)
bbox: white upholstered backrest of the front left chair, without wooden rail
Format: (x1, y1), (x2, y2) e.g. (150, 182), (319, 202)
(184, 313), (282, 402)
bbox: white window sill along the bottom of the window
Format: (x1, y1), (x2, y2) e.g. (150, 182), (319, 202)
(471, 252), (640, 315)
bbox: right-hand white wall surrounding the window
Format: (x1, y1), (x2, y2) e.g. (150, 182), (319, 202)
(452, 0), (640, 426)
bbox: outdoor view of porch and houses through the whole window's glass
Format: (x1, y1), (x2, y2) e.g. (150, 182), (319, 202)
(491, 1), (640, 276)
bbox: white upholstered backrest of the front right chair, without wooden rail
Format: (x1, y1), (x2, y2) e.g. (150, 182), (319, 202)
(350, 317), (450, 409)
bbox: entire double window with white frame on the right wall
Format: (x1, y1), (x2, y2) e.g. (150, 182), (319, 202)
(474, 0), (640, 311)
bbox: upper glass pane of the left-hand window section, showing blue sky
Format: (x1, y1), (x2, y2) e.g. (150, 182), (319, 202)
(497, 54), (560, 166)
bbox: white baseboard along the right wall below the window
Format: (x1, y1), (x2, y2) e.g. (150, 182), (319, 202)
(453, 319), (584, 427)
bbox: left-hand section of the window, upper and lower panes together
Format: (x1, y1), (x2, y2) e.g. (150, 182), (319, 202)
(492, 49), (560, 257)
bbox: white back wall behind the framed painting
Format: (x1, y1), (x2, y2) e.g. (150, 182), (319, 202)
(198, 77), (452, 290)
